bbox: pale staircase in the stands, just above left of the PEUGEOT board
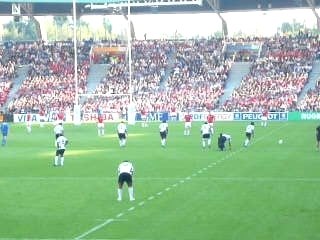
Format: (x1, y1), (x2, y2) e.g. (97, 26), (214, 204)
(219, 62), (251, 106)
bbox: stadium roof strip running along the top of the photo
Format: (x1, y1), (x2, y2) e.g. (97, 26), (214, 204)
(0, 0), (320, 16)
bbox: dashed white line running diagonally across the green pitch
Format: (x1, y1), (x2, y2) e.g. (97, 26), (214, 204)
(75, 124), (288, 240)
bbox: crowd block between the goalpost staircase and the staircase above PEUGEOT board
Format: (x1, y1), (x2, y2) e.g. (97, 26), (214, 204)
(84, 39), (231, 112)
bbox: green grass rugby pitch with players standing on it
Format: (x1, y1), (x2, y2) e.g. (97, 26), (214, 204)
(0, 122), (320, 240)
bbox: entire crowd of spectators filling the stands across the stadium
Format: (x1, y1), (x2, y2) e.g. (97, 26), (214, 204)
(0, 36), (320, 115)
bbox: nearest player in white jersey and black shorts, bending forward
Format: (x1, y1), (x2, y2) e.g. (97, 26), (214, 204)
(118, 160), (135, 201)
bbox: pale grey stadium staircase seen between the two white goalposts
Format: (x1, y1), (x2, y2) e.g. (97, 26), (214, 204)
(87, 64), (108, 93)
